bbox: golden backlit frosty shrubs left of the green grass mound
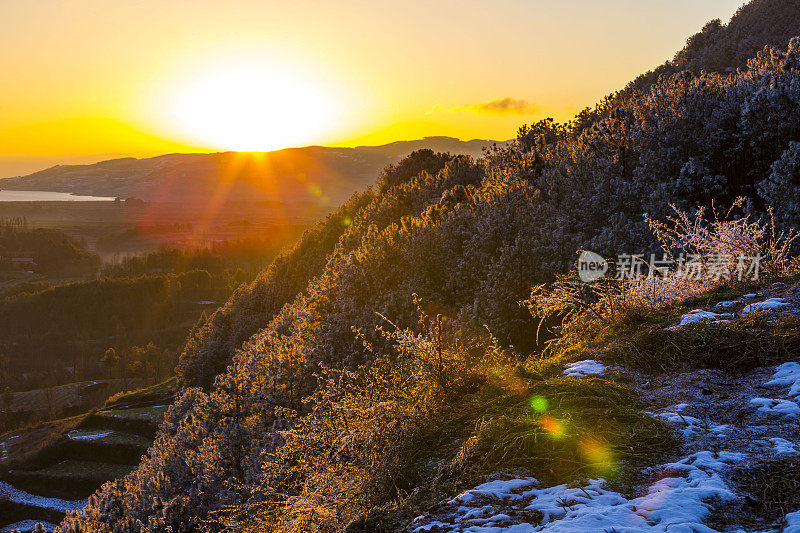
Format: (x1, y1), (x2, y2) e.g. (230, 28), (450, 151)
(219, 314), (507, 533)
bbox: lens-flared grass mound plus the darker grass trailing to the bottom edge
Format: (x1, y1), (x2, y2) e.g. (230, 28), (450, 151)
(336, 374), (679, 533)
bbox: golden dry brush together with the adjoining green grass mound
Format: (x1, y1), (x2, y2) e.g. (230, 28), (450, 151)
(222, 318), (676, 533)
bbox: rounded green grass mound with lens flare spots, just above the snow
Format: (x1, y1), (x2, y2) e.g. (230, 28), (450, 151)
(444, 377), (677, 484)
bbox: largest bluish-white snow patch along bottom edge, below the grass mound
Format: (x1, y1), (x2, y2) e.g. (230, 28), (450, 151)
(412, 451), (745, 533)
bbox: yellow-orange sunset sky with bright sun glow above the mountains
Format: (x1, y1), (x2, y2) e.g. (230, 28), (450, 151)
(0, 0), (744, 177)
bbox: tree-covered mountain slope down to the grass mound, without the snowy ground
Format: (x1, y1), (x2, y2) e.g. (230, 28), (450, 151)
(62, 5), (800, 533)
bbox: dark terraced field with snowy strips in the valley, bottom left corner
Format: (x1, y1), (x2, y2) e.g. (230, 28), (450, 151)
(0, 381), (174, 532)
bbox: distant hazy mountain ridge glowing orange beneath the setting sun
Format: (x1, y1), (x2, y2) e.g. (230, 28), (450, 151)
(0, 137), (505, 205)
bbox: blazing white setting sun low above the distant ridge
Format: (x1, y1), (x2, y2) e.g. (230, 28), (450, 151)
(173, 65), (336, 152)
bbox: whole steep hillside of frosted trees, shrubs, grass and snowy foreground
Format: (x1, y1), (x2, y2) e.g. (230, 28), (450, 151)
(45, 25), (800, 532)
